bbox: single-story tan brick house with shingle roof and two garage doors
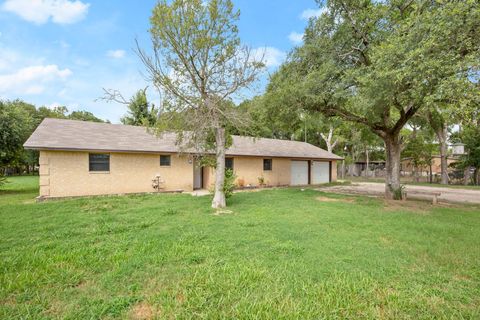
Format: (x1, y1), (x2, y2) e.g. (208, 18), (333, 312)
(24, 119), (342, 198)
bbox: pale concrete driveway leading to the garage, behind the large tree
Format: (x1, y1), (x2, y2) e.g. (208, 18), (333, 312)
(321, 182), (480, 204)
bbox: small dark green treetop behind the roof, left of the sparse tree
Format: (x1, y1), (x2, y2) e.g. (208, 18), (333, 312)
(120, 88), (158, 127)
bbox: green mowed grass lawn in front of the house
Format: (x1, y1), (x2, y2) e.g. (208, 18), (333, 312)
(0, 177), (480, 319)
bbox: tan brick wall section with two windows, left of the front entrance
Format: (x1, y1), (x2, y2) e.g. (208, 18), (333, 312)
(40, 151), (193, 197)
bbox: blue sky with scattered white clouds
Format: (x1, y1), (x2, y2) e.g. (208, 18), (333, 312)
(0, 0), (321, 123)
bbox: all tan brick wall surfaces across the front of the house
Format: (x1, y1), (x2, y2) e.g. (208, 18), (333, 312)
(40, 151), (337, 197)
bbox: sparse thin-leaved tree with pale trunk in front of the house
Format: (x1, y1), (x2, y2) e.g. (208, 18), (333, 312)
(137, 0), (263, 208)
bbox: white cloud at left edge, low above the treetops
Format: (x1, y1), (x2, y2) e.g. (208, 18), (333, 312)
(0, 64), (72, 95)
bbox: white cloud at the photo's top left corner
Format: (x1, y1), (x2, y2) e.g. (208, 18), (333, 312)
(2, 0), (90, 24)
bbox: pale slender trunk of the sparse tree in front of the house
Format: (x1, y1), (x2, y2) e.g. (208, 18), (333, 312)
(212, 128), (227, 209)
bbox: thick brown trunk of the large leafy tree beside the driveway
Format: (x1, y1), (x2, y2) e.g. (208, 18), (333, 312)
(384, 134), (403, 200)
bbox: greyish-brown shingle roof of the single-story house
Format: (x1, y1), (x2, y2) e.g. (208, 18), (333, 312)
(24, 118), (342, 160)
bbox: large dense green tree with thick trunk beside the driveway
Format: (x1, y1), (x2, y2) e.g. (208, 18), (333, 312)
(269, 0), (480, 198)
